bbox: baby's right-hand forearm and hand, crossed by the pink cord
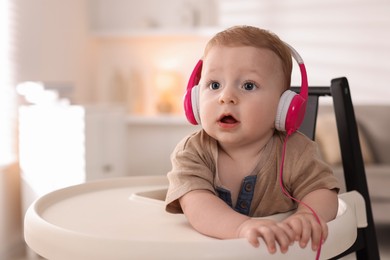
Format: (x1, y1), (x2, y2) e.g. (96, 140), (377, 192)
(283, 189), (338, 250)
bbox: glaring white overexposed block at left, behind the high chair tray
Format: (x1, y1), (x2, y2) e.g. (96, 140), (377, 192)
(19, 105), (86, 196)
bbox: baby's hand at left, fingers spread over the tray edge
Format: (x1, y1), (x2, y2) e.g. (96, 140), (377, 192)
(238, 219), (297, 254)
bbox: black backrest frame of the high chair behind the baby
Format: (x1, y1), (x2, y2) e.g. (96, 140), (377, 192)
(291, 77), (380, 260)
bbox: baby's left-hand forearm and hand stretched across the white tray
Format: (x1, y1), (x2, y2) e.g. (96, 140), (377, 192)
(180, 190), (296, 253)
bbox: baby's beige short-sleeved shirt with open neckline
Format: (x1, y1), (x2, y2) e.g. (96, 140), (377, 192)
(166, 130), (339, 217)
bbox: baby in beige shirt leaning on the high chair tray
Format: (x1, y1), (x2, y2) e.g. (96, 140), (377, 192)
(166, 26), (339, 253)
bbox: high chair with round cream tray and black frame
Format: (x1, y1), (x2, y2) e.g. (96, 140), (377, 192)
(24, 78), (379, 260)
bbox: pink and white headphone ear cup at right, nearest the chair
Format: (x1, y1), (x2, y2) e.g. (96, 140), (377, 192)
(275, 90), (306, 134)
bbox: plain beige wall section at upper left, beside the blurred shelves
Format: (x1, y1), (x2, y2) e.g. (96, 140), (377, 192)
(15, 0), (93, 101)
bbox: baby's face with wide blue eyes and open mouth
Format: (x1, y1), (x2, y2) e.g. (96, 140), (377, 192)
(199, 46), (284, 145)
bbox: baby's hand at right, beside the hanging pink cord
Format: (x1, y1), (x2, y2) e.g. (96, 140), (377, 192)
(283, 211), (328, 251)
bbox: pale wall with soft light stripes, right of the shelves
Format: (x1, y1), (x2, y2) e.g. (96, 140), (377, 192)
(218, 0), (390, 104)
